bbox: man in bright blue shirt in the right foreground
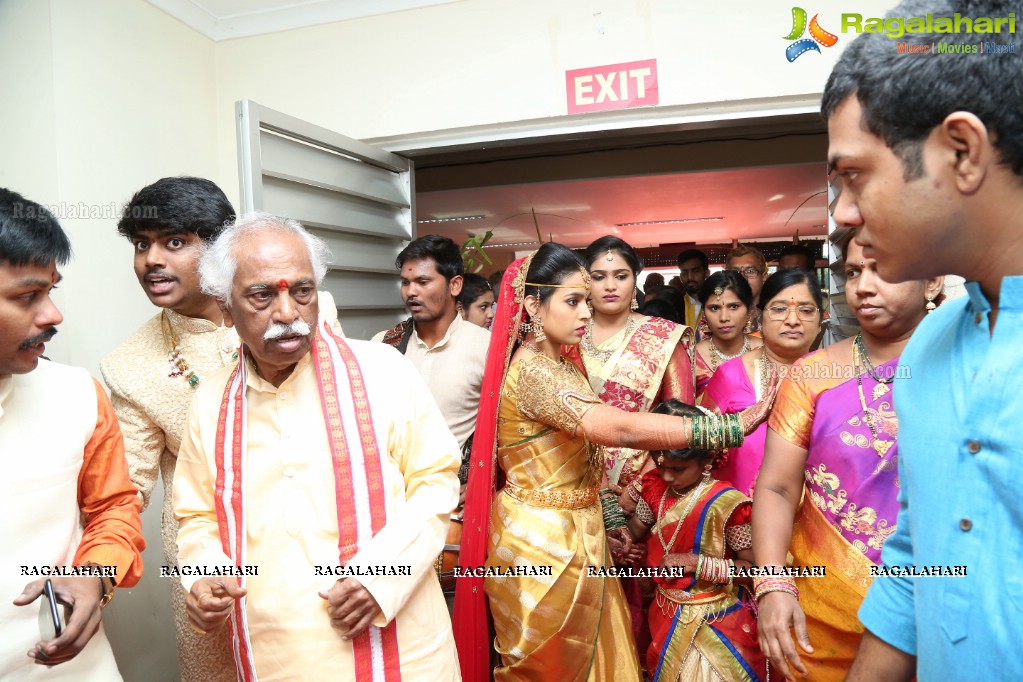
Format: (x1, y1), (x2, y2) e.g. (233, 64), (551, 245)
(821, 0), (1023, 682)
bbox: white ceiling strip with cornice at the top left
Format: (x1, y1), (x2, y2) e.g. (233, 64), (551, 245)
(148, 0), (458, 41)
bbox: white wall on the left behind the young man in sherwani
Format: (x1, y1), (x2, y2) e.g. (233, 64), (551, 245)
(0, 0), (221, 682)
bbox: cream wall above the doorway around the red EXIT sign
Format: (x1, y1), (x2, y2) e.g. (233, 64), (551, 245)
(217, 0), (895, 172)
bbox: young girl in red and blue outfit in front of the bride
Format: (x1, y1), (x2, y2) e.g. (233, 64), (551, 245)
(629, 401), (766, 682)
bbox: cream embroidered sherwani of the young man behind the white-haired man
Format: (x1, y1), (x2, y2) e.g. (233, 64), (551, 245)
(99, 291), (341, 682)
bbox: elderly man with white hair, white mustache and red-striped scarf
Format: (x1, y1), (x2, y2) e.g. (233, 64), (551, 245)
(174, 214), (459, 681)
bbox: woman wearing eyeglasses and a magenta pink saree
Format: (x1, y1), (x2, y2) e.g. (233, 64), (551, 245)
(701, 270), (822, 495)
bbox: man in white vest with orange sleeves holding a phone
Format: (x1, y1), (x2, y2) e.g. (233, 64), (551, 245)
(0, 188), (145, 681)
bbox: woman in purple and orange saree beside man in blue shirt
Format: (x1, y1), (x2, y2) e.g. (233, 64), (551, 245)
(753, 236), (942, 681)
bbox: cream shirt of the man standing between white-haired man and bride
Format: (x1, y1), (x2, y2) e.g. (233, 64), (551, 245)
(373, 315), (490, 446)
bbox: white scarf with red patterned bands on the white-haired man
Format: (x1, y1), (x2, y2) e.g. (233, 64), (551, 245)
(214, 320), (401, 682)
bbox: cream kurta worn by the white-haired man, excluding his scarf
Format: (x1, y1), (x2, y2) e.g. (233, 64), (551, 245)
(174, 340), (459, 682)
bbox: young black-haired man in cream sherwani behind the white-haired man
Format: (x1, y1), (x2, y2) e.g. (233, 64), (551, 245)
(100, 177), (340, 682)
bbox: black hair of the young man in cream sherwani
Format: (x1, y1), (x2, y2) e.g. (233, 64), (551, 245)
(118, 177), (235, 243)
